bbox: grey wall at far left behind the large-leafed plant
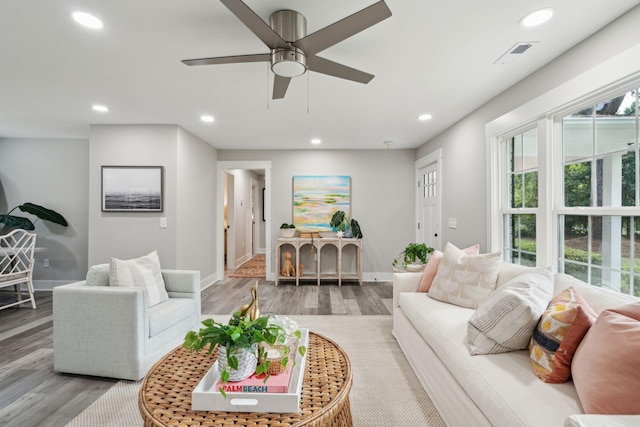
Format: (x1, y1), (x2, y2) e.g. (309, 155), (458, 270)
(0, 138), (89, 289)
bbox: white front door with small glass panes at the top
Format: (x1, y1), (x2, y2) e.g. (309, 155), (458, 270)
(416, 149), (442, 249)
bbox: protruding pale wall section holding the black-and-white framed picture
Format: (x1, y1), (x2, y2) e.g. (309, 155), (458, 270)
(89, 125), (217, 285)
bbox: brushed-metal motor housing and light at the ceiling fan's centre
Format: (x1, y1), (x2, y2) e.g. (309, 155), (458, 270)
(270, 10), (307, 77)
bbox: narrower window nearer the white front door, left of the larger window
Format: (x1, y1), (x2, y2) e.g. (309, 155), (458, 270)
(501, 129), (538, 266)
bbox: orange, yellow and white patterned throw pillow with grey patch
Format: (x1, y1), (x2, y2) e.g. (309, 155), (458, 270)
(529, 287), (597, 383)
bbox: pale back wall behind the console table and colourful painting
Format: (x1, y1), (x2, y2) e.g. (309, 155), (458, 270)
(218, 150), (415, 280)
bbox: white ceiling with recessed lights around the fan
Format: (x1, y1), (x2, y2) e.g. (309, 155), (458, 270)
(0, 0), (640, 149)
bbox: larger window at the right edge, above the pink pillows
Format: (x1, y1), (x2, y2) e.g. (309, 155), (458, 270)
(557, 90), (640, 296)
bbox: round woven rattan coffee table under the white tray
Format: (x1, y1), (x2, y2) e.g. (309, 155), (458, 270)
(138, 332), (353, 427)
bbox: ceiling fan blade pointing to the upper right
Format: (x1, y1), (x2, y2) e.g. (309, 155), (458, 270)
(294, 0), (391, 56)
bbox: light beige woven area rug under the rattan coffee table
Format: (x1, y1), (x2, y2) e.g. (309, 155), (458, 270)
(67, 315), (445, 427)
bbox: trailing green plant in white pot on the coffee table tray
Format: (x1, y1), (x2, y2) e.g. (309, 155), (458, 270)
(182, 311), (306, 396)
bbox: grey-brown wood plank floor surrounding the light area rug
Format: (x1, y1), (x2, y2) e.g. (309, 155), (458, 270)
(0, 279), (393, 427)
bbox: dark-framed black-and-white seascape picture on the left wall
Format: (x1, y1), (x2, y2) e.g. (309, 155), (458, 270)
(102, 166), (164, 212)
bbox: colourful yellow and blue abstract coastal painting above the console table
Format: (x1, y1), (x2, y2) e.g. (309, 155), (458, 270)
(293, 175), (351, 231)
